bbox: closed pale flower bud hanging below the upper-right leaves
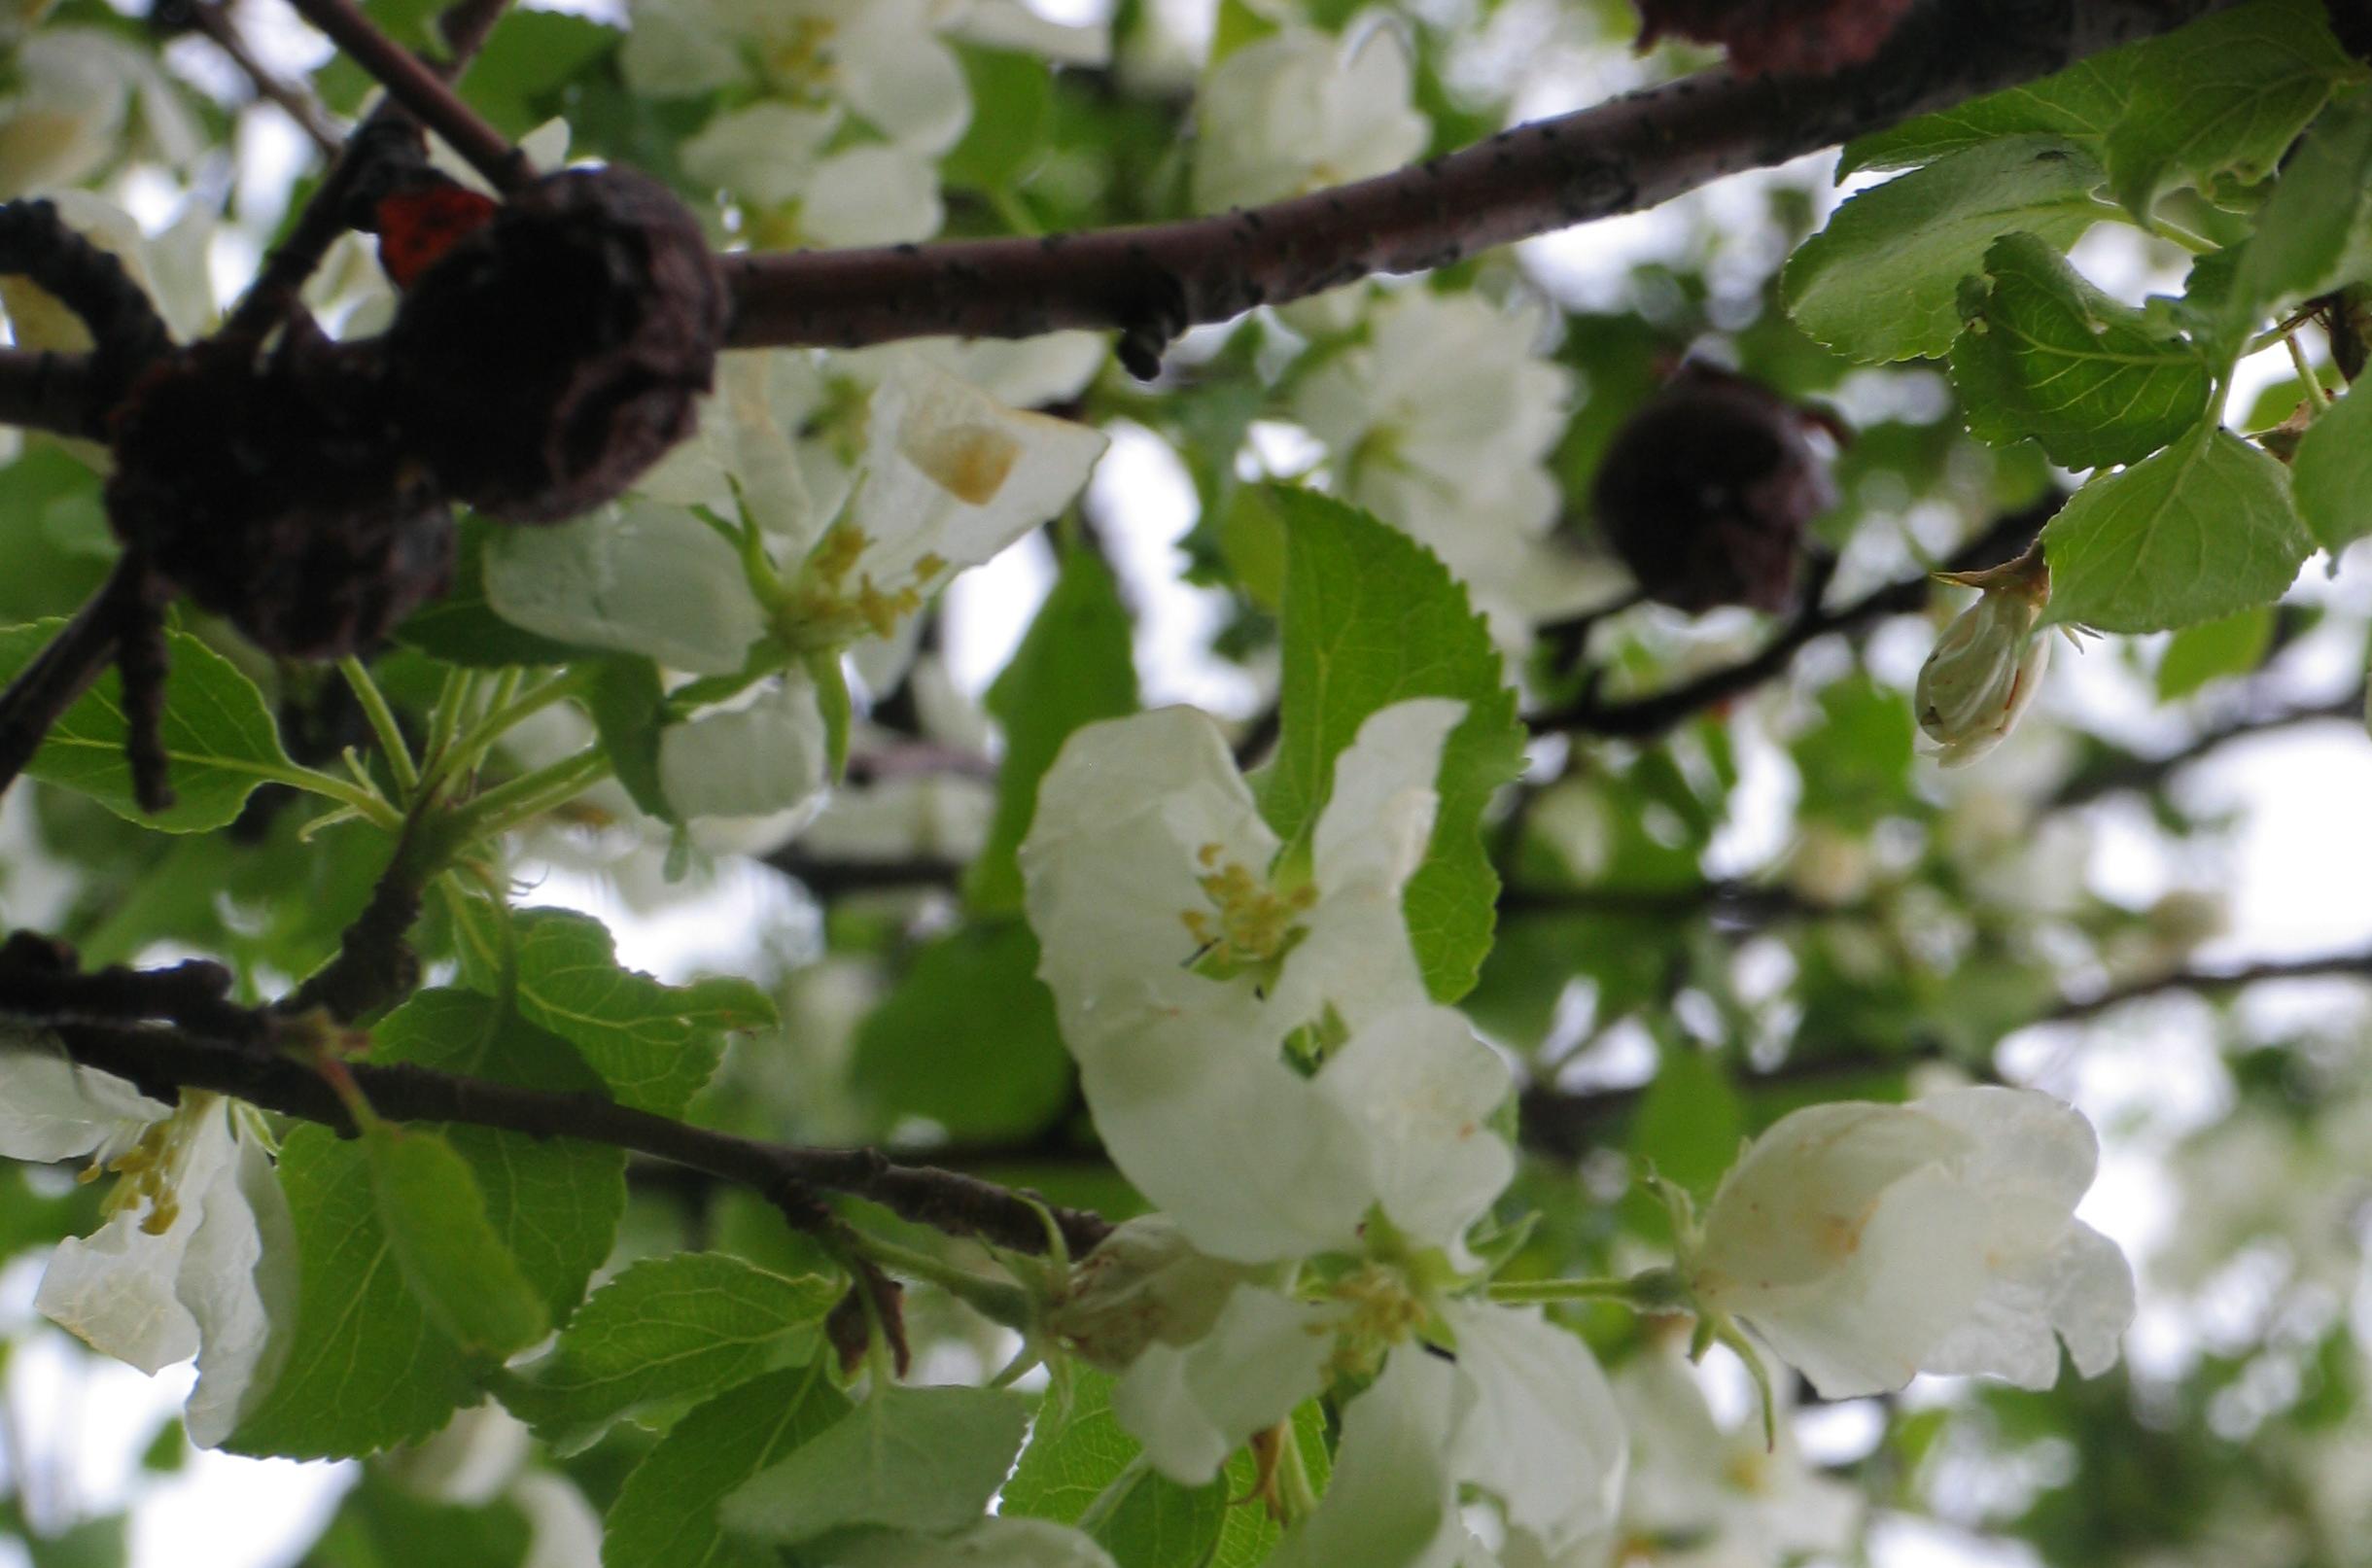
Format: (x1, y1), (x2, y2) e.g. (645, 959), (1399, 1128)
(1912, 548), (2052, 769)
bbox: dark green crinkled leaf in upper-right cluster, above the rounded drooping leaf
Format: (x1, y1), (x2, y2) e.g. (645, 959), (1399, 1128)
(1952, 235), (2214, 468)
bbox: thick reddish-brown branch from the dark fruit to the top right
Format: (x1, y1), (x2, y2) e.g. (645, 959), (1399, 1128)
(726, 0), (2214, 363)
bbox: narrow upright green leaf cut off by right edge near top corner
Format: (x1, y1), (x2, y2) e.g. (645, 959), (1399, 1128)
(2234, 104), (2372, 316)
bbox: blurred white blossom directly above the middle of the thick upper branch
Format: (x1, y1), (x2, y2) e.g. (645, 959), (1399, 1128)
(1193, 26), (1430, 211)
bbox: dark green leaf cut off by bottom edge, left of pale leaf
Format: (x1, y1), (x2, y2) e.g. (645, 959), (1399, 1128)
(600, 1359), (850, 1568)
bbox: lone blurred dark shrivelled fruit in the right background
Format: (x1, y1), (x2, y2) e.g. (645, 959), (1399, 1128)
(1591, 366), (1836, 614)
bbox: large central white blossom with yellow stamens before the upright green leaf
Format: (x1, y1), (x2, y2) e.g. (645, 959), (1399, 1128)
(1023, 700), (1514, 1262)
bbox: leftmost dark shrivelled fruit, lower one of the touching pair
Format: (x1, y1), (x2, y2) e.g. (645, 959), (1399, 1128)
(107, 330), (453, 659)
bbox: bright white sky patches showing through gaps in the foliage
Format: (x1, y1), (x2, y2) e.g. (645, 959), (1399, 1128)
(14, 0), (2372, 1568)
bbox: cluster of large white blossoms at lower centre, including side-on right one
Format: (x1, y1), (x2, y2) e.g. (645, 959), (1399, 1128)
(1023, 700), (2133, 1566)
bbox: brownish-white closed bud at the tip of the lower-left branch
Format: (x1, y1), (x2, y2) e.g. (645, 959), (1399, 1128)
(1048, 1214), (1250, 1371)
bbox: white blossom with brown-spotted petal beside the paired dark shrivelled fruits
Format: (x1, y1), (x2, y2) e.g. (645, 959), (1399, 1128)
(484, 354), (1105, 820)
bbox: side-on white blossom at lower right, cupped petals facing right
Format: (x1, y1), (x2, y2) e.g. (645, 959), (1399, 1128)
(1687, 1089), (2135, 1400)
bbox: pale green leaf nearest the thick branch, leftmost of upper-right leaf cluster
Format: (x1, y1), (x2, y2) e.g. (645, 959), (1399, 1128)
(1781, 135), (2102, 363)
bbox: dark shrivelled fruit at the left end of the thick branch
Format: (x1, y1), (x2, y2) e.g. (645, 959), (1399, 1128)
(387, 168), (726, 522)
